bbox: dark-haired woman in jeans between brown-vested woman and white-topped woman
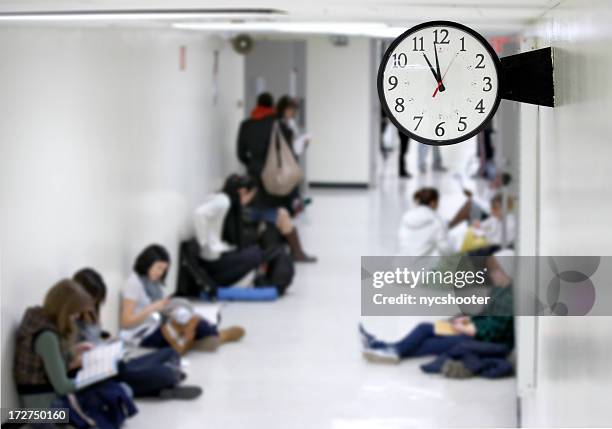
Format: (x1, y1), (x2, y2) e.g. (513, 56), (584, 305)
(73, 268), (202, 399)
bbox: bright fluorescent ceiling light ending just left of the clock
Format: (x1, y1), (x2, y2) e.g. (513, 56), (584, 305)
(172, 21), (392, 36)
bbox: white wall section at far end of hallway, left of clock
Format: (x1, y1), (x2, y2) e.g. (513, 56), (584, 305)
(306, 37), (372, 184)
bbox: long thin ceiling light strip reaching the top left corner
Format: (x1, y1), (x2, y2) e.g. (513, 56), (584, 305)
(0, 9), (285, 22)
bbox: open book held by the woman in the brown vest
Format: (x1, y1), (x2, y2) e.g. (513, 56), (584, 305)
(75, 341), (124, 389)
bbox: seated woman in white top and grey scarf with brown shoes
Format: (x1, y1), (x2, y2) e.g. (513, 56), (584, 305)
(120, 244), (244, 354)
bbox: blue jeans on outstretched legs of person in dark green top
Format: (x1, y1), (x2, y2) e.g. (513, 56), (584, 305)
(389, 323), (471, 358)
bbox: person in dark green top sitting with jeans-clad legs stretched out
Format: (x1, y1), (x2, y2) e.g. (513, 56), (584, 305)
(359, 256), (514, 363)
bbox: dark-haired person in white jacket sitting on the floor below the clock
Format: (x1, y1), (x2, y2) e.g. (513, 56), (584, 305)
(398, 188), (452, 256)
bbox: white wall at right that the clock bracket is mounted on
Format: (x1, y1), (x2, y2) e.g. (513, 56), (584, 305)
(519, 0), (612, 427)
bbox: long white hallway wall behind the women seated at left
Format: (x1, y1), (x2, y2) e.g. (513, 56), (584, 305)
(0, 28), (244, 407)
